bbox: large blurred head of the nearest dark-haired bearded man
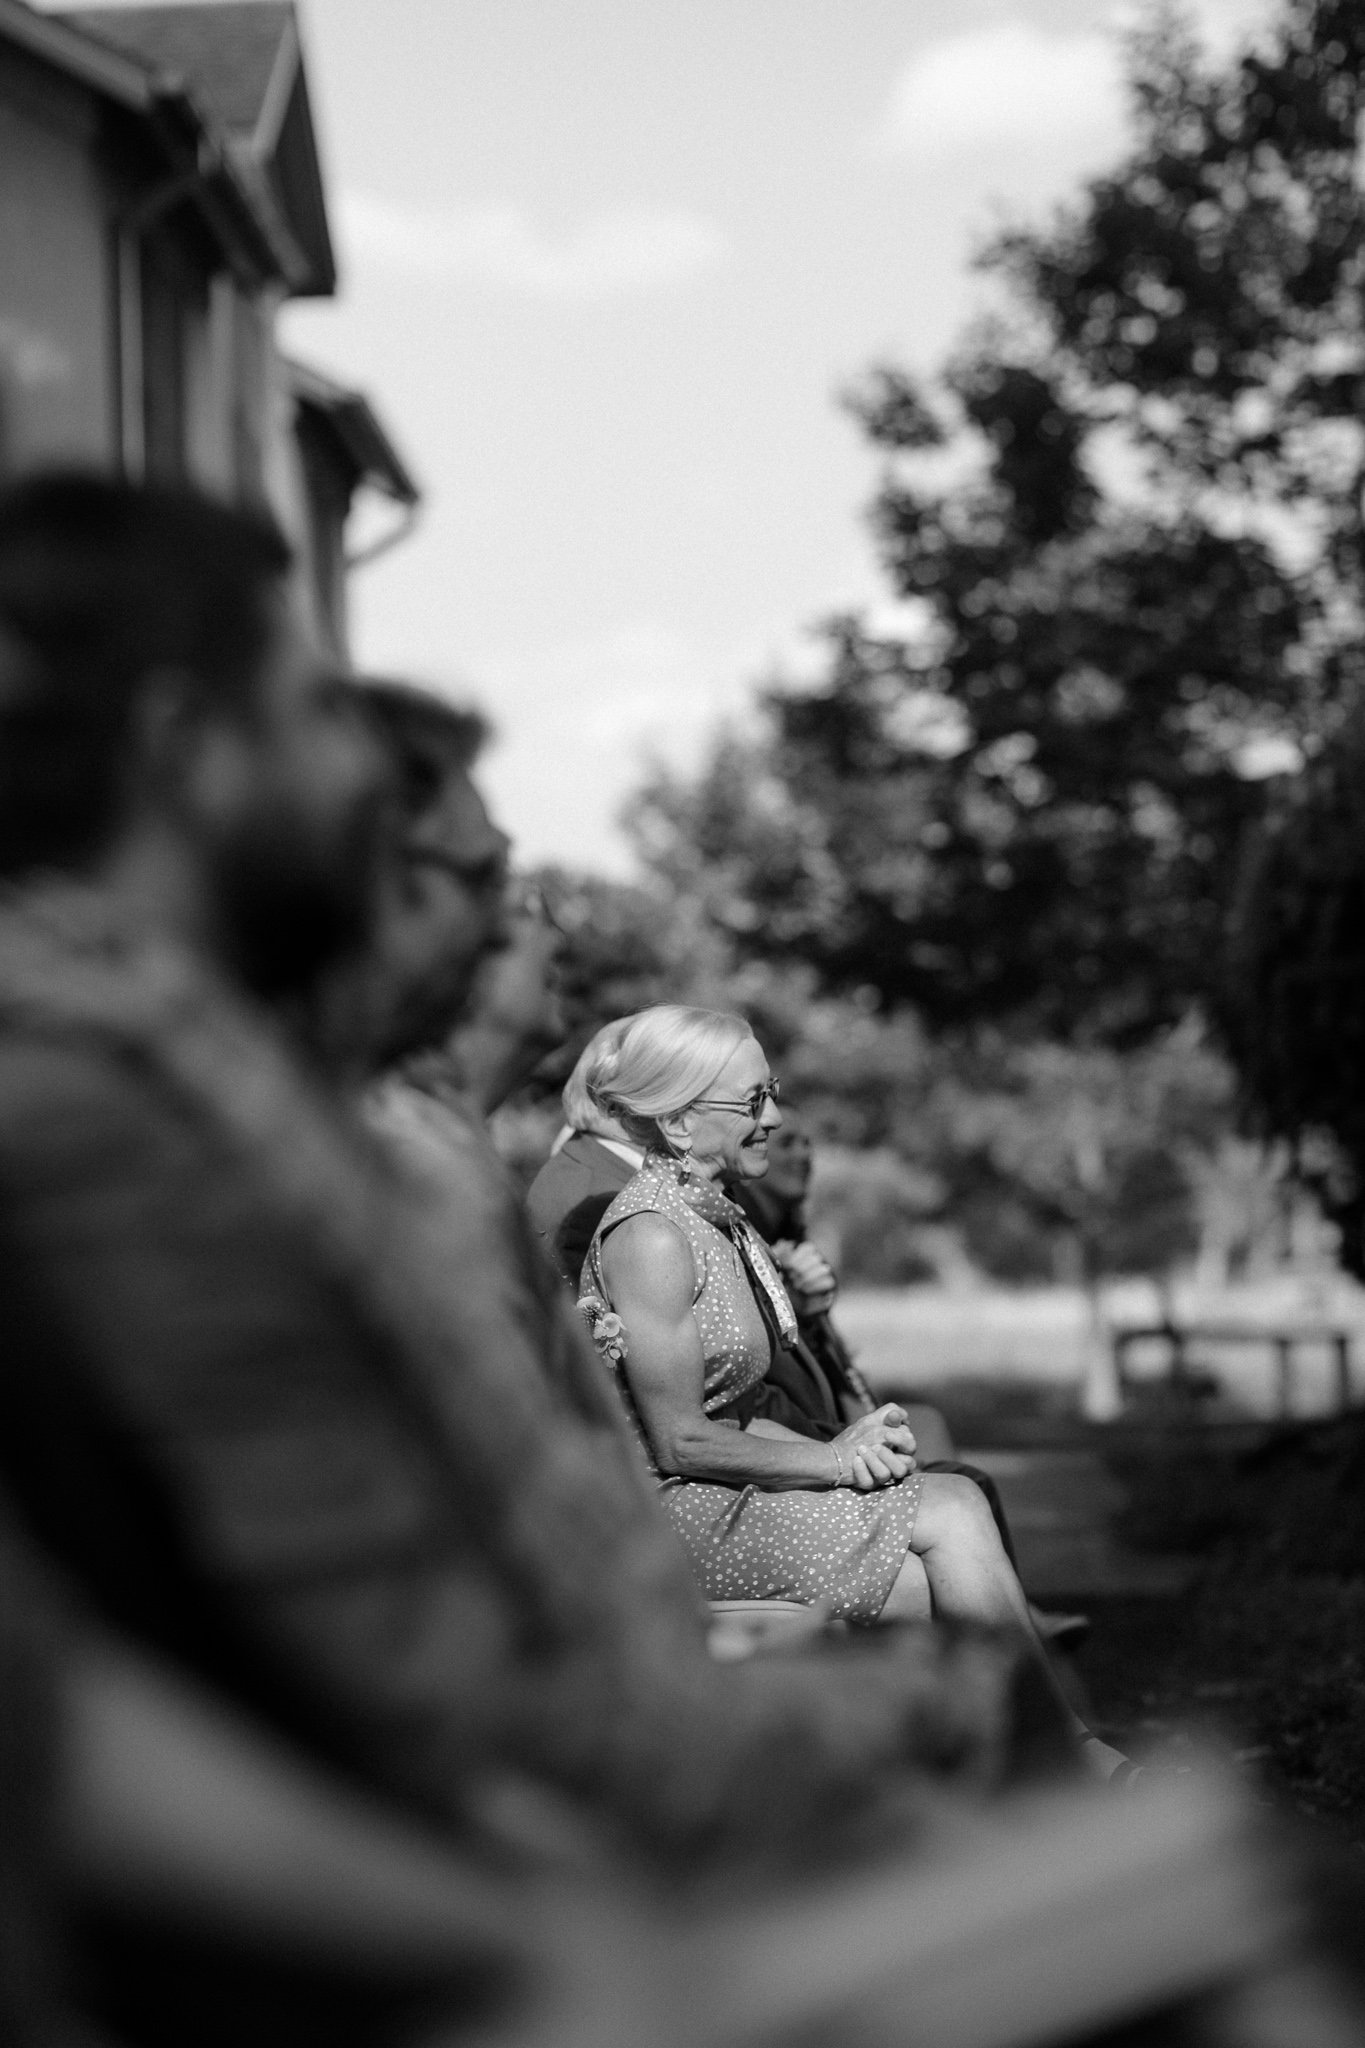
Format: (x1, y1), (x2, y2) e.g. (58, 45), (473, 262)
(0, 473), (379, 995)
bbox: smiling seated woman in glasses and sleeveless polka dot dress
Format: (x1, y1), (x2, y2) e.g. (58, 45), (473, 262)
(579, 1004), (1124, 1776)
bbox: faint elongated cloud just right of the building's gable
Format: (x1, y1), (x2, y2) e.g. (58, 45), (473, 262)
(336, 193), (726, 299)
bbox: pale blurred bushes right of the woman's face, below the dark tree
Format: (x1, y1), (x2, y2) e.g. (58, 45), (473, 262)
(778, 999), (1279, 1286)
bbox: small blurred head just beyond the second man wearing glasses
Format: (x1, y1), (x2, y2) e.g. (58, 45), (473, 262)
(435, 883), (567, 1116)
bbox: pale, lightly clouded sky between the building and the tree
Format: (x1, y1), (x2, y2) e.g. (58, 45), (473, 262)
(93, 0), (1285, 868)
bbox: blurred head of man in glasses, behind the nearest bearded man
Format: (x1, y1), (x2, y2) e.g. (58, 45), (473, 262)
(347, 678), (510, 1067)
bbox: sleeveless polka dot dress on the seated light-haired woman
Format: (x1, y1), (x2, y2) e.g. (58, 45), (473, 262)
(581, 1153), (923, 1622)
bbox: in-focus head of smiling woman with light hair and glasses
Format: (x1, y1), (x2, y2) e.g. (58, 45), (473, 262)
(589, 1004), (782, 1180)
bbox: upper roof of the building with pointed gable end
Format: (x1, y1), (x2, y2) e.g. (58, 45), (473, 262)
(45, 0), (336, 297)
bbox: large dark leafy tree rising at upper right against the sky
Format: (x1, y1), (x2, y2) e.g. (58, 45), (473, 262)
(632, 0), (1365, 1044)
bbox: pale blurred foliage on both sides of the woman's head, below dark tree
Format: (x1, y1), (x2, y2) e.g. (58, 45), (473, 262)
(519, 870), (1277, 1284)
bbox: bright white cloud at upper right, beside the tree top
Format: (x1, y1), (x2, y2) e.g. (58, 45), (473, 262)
(874, 20), (1124, 162)
